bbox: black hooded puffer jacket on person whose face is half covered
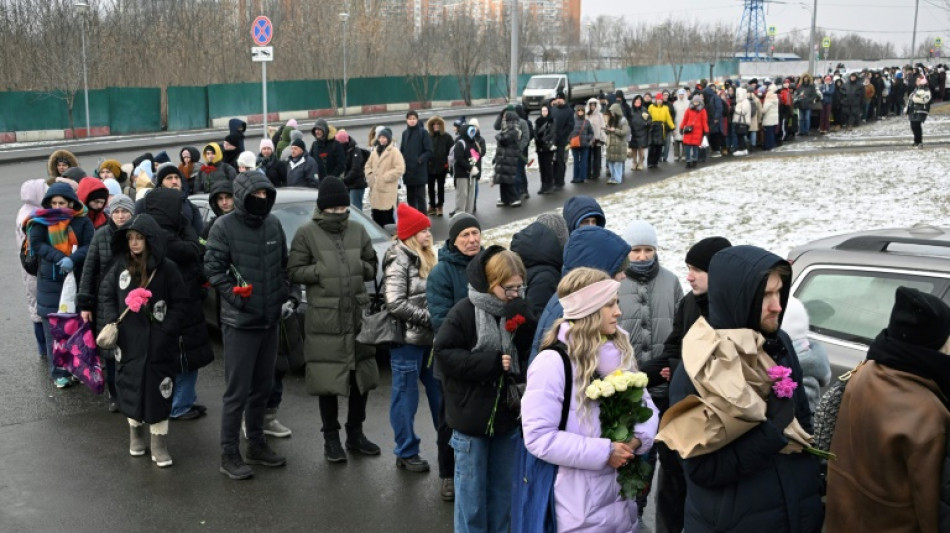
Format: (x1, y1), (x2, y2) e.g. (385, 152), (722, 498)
(204, 172), (289, 329)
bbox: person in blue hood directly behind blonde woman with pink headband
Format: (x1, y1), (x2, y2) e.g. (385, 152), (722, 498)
(529, 226), (630, 363)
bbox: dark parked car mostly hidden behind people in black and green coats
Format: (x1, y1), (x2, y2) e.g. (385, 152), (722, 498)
(188, 187), (392, 327)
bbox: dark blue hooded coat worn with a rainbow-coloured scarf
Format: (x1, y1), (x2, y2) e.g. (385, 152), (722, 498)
(29, 183), (95, 318)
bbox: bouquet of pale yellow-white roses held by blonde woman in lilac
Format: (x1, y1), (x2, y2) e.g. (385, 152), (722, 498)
(584, 370), (653, 500)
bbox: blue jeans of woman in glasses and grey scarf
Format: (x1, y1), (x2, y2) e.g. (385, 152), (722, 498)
(451, 428), (518, 533)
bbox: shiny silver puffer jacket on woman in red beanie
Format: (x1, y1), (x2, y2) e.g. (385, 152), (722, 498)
(383, 241), (433, 346)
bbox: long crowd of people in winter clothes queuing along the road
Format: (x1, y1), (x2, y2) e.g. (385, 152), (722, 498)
(16, 64), (950, 532)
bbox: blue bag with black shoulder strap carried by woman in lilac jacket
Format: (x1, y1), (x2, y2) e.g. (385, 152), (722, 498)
(510, 342), (574, 533)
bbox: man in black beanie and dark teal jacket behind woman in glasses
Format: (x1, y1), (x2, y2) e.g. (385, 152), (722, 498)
(426, 212), (482, 501)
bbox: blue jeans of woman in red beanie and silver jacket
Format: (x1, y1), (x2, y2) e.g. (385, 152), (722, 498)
(389, 344), (442, 458)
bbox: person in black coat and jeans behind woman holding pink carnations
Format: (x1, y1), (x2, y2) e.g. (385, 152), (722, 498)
(142, 189), (214, 420)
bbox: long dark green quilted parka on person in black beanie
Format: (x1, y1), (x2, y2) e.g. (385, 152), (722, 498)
(287, 209), (379, 396)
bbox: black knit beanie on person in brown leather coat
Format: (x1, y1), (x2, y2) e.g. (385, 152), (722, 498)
(887, 287), (950, 350)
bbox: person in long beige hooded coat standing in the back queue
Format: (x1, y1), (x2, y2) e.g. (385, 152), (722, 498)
(366, 128), (406, 227)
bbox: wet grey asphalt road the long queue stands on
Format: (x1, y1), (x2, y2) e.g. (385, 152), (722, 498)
(0, 110), (692, 532)
